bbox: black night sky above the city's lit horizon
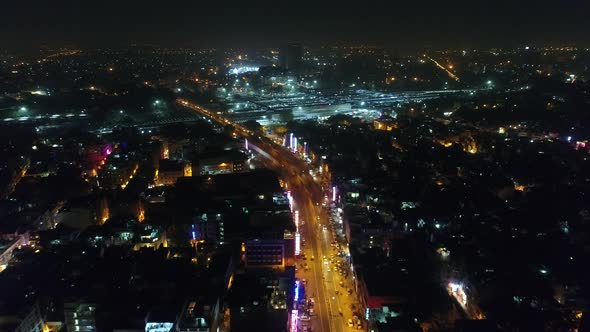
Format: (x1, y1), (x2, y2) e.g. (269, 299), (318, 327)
(0, 0), (590, 49)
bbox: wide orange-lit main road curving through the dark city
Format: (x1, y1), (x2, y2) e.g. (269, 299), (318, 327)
(177, 99), (364, 332)
